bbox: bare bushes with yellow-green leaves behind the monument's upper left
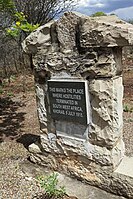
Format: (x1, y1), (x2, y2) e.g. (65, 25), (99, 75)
(0, 0), (78, 76)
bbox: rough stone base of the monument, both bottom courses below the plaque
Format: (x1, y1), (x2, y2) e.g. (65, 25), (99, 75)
(29, 135), (133, 198)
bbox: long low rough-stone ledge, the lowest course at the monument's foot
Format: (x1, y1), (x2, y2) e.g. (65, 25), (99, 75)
(30, 150), (133, 199)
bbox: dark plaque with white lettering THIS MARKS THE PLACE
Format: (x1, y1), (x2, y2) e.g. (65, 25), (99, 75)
(48, 80), (89, 124)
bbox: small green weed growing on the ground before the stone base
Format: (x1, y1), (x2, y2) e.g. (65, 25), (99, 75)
(37, 173), (66, 199)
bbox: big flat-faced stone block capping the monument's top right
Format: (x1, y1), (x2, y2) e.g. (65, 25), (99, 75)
(80, 16), (133, 48)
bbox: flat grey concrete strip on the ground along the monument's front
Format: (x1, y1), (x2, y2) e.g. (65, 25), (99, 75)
(19, 161), (126, 199)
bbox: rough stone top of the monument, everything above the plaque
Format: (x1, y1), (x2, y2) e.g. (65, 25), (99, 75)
(23, 12), (133, 78)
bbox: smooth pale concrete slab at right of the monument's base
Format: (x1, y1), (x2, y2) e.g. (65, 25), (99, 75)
(114, 156), (133, 178)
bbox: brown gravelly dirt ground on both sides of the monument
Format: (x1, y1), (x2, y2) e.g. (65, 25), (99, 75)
(0, 71), (133, 199)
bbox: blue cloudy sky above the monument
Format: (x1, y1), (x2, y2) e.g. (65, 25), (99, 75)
(76, 0), (133, 20)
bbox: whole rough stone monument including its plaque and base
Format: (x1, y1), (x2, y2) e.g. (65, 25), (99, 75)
(23, 12), (133, 196)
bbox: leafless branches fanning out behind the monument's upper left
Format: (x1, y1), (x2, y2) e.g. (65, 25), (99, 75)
(14, 0), (78, 25)
